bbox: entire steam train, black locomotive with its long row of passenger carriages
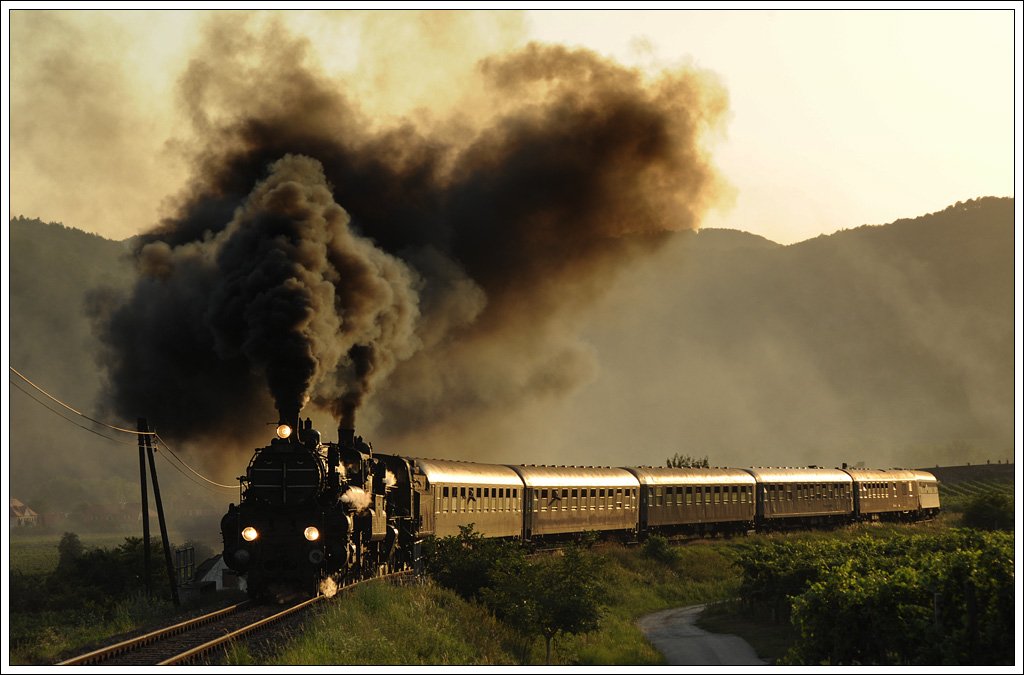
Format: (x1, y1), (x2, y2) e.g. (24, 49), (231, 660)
(221, 413), (940, 598)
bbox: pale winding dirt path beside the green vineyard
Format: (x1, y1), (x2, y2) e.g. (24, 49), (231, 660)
(637, 604), (766, 666)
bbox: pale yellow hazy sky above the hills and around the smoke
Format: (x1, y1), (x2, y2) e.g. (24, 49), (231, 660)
(3, 3), (1021, 244)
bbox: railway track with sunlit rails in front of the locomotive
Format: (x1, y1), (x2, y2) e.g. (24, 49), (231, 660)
(56, 573), (409, 666)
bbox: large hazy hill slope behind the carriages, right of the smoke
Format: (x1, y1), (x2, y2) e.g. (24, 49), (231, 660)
(561, 198), (1015, 468)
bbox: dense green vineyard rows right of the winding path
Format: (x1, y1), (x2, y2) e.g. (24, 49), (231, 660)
(737, 530), (1014, 665)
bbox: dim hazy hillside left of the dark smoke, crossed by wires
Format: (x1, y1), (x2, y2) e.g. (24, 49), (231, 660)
(8, 218), (138, 487)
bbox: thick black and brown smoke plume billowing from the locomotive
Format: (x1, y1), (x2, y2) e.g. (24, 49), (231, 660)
(90, 15), (727, 450)
